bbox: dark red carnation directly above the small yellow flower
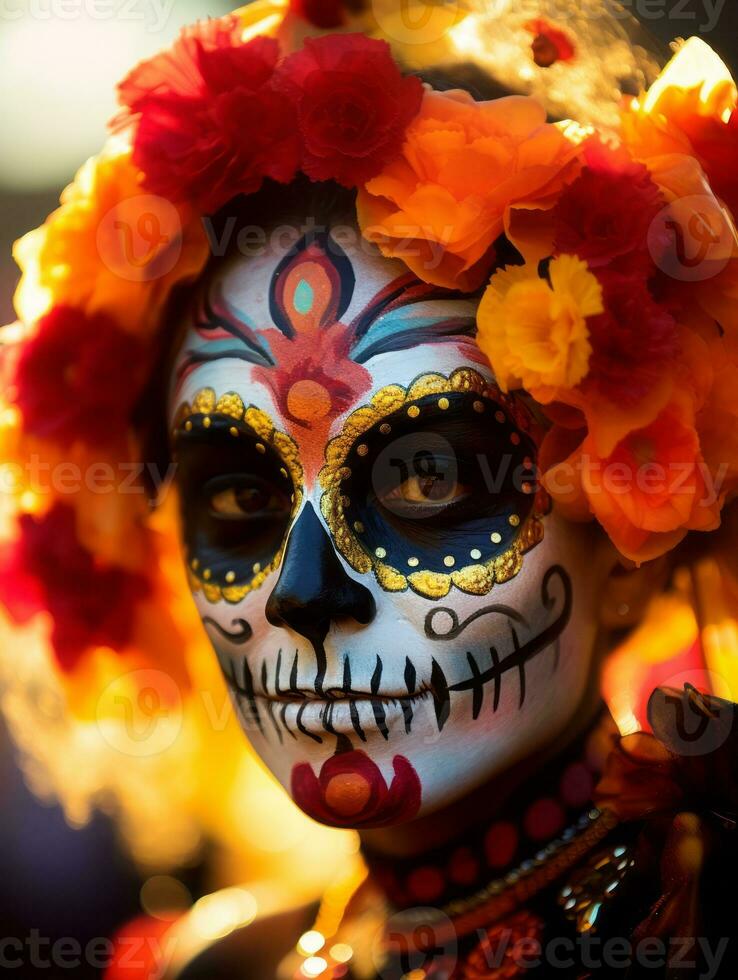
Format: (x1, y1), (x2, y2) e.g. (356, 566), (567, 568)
(553, 147), (665, 276)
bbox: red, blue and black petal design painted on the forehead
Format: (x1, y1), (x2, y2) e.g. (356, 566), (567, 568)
(177, 231), (475, 424)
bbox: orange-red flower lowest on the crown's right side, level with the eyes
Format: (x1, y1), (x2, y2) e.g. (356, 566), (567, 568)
(542, 395), (721, 562)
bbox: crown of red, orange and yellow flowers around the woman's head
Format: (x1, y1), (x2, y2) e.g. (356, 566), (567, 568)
(0, 4), (738, 674)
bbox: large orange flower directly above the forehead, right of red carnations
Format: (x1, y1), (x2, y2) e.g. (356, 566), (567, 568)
(357, 90), (579, 290)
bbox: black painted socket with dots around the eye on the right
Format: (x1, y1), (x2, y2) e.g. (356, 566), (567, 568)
(342, 392), (536, 573)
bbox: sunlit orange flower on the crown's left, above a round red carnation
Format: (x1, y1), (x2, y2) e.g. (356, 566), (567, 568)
(14, 148), (209, 334)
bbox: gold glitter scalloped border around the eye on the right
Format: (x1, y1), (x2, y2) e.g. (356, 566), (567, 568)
(318, 368), (543, 599)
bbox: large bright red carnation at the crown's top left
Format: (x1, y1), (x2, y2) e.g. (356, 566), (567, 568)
(119, 16), (299, 213)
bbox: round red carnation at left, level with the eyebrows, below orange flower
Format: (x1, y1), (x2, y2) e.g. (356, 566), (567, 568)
(14, 306), (145, 446)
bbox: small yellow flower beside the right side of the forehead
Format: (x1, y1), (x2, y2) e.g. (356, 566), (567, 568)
(477, 255), (604, 402)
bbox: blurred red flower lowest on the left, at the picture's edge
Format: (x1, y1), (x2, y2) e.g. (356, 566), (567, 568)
(0, 503), (149, 670)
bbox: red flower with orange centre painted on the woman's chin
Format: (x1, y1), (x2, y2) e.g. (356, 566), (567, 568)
(291, 750), (421, 827)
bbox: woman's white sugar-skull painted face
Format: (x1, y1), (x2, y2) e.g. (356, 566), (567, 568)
(170, 212), (604, 827)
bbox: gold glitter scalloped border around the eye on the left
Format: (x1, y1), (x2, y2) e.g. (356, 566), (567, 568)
(175, 388), (304, 603)
